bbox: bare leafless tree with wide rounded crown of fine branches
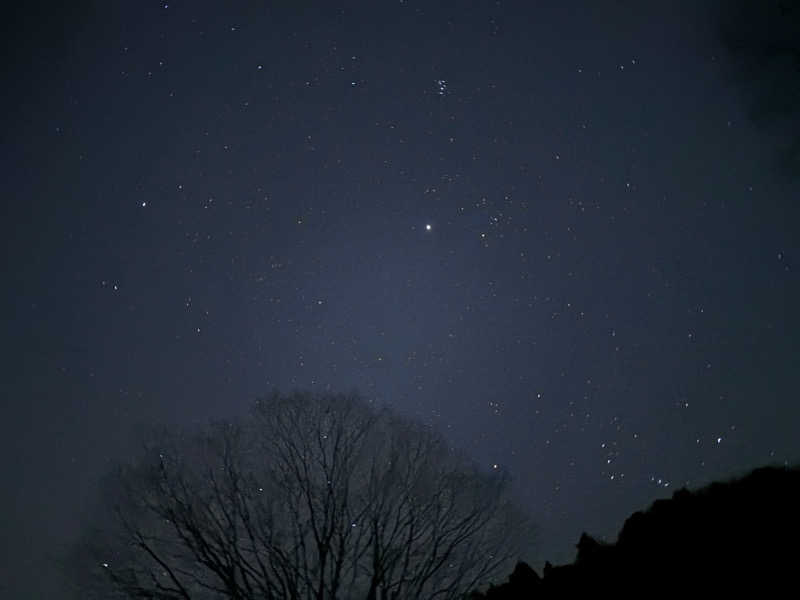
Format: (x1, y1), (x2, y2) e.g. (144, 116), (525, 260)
(72, 394), (531, 600)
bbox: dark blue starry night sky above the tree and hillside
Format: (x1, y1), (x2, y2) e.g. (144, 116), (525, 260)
(0, 0), (800, 598)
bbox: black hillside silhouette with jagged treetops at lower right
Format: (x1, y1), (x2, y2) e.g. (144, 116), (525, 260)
(473, 467), (800, 600)
